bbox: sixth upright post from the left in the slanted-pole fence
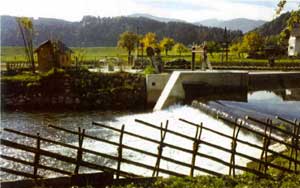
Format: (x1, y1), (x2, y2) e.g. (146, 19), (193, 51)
(229, 119), (243, 176)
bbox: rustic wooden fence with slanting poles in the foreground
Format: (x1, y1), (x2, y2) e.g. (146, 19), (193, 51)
(0, 117), (300, 179)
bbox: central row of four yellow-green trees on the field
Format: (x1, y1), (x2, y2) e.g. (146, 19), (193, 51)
(118, 31), (188, 60)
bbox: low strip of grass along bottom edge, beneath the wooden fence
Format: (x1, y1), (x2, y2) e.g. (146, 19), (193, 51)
(110, 174), (300, 188)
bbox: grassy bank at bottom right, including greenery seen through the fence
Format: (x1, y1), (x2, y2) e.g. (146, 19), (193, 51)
(110, 147), (300, 188)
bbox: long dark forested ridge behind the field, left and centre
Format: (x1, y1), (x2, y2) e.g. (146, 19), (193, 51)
(1, 16), (242, 47)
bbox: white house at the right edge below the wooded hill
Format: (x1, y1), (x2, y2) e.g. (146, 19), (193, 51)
(288, 25), (300, 56)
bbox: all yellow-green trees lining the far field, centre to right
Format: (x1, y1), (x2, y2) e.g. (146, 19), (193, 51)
(118, 31), (286, 61)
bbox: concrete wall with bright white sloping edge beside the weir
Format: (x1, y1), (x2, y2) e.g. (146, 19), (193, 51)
(147, 71), (300, 111)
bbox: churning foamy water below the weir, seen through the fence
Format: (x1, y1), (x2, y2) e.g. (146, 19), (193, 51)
(1, 105), (262, 179)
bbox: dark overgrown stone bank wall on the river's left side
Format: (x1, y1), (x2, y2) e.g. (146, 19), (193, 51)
(1, 71), (146, 110)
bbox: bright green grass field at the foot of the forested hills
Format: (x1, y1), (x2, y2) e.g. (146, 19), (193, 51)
(1, 47), (300, 63)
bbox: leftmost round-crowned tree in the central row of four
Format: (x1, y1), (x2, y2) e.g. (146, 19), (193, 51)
(118, 31), (139, 63)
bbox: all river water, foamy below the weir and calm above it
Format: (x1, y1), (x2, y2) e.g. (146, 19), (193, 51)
(0, 86), (300, 180)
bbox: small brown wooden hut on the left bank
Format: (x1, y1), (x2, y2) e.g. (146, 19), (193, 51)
(34, 40), (73, 72)
